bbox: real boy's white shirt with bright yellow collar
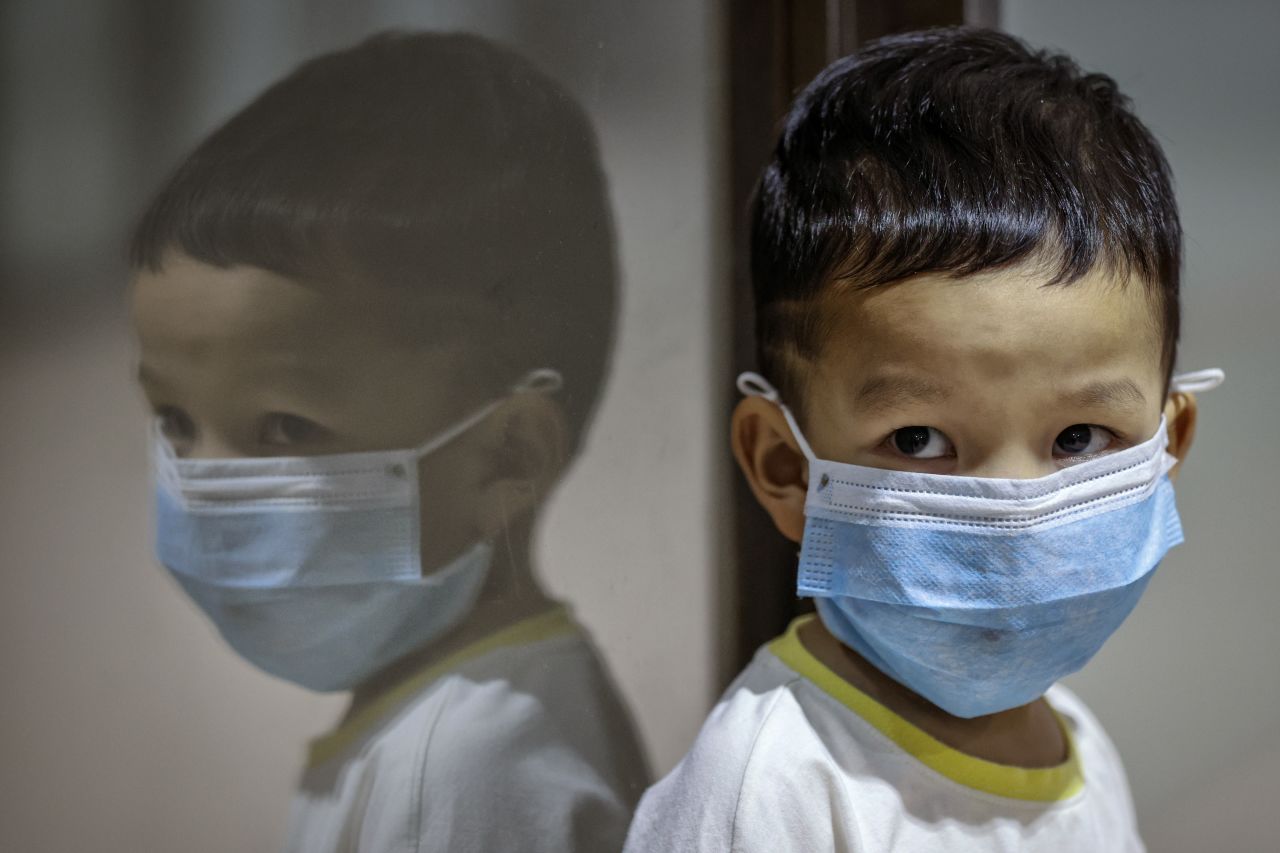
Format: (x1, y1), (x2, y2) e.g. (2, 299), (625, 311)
(626, 616), (1143, 853)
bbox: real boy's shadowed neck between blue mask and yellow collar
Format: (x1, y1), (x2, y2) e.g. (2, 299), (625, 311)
(800, 619), (1068, 767)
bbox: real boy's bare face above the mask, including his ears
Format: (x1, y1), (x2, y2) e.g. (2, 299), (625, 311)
(733, 258), (1194, 539)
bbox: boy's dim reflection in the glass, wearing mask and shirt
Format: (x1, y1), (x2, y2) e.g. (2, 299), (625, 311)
(132, 29), (646, 853)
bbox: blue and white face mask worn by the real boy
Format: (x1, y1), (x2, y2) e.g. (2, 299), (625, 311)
(739, 371), (1221, 717)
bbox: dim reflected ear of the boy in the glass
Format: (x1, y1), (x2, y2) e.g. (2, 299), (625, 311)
(476, 392), (568, 537)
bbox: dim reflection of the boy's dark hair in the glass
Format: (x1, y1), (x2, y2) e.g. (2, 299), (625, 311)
(131, 33), (617, 450)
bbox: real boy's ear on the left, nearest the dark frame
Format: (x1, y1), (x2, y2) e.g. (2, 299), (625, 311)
(730, 397), (809, 542)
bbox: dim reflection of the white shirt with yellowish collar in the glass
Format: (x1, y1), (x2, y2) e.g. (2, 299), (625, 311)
(287, 610), (648, 853)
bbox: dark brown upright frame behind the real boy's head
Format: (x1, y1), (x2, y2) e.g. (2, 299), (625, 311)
(719, 0), (998, 685)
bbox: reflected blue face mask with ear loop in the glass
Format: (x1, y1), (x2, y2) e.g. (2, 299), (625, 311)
(154, 370), (561, 690)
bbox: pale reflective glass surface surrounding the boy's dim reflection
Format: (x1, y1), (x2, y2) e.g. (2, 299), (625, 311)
(0, 0), (726, 853)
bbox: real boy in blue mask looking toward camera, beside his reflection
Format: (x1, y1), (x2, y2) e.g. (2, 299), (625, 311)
(627, 28), (1220, 853)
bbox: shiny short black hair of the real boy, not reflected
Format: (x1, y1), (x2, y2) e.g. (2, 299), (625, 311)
(751, 27), (1181, 398)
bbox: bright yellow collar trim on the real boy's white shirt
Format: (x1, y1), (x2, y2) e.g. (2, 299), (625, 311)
(768, 613), (1084, 803)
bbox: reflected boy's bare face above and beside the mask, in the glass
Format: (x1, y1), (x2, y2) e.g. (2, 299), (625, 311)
(132, 254), (560, 566)
